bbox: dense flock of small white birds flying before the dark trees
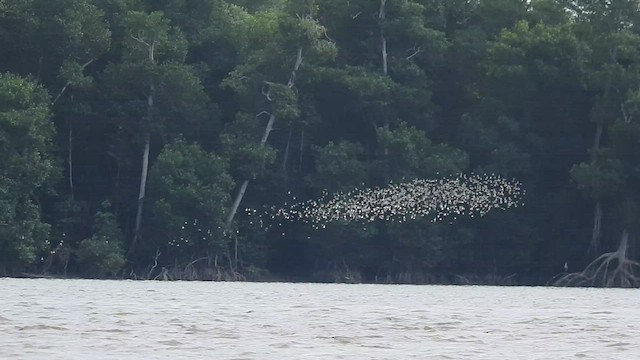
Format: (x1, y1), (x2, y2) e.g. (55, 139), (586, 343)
(245, 175), (525, 229)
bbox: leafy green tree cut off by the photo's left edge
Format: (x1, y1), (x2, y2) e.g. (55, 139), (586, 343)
(0, 73), (56, 270)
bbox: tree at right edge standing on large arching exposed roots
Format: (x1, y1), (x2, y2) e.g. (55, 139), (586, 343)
(556, 1), (640, 287)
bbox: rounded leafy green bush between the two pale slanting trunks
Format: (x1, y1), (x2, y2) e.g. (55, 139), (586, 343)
(147, 139), (234, 260)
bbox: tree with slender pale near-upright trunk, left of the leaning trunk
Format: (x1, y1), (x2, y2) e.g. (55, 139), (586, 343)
(105, 11), (207, 254)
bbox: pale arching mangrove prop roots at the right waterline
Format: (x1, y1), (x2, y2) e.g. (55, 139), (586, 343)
(553, 230), (640, 288)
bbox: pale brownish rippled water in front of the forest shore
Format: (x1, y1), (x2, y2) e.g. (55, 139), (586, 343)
(0, 279), (640, 360)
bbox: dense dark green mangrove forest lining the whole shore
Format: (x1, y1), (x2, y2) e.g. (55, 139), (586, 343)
(0, 0), (640, 286)
